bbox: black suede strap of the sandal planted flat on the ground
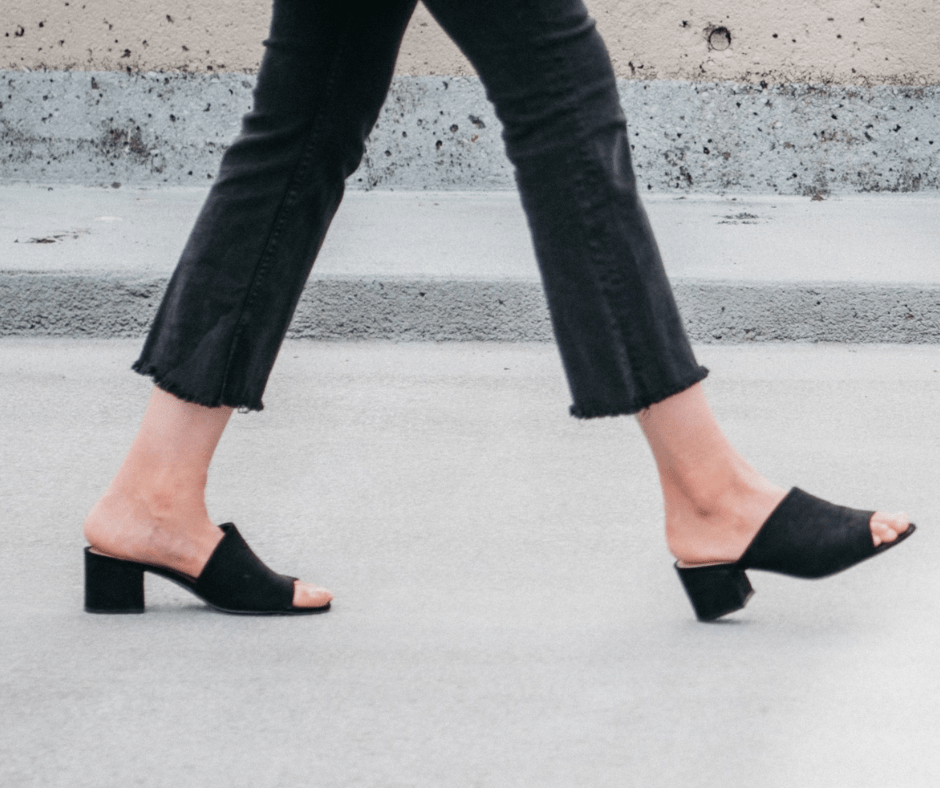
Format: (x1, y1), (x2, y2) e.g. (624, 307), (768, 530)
(193, 523), (296, 613)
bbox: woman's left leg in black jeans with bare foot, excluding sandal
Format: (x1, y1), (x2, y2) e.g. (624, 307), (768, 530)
(85, 0), (415, 607)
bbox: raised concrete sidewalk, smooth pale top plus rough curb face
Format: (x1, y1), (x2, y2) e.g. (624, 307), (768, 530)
(0, 185), (940, 343)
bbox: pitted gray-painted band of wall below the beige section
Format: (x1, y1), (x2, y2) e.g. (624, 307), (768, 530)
(0, 71), (940, 195)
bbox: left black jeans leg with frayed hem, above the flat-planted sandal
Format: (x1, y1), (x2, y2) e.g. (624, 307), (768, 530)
(134, 0), (416, 410)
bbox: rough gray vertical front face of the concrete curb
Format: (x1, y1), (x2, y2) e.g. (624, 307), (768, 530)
(0, 272), (940, 344)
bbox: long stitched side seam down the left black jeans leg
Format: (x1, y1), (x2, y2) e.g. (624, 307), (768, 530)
(219, 18), (352, 399)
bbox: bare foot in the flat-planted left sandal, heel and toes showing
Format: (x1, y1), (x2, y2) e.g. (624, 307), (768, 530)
(85, 489), (333, 607)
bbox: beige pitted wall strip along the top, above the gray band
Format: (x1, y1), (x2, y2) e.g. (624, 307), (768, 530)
(0, 0), (940, 85)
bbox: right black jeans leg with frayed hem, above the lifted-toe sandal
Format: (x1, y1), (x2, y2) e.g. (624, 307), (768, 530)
(425, 0), (707, 418)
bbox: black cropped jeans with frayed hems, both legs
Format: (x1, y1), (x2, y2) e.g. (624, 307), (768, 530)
(134, 0), (707, 417)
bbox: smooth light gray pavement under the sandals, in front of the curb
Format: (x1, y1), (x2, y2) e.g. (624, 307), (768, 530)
(0, 339), (940, 788)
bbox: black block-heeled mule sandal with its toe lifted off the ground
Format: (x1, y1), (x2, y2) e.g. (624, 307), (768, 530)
(676, 487), (915, 621)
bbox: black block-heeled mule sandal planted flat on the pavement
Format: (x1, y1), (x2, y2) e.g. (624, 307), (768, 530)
(85, 523), (330, 616)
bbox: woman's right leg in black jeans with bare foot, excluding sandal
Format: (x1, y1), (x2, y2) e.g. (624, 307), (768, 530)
(425, 0), (907, 563)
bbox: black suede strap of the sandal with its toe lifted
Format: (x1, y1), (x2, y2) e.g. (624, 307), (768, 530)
(738, 487), (888, 577)
